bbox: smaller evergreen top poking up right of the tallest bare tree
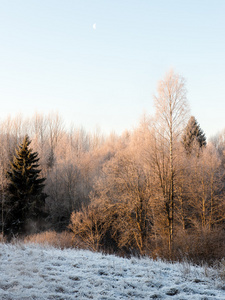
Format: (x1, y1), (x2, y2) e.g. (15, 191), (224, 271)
(182, 116), (206, 154)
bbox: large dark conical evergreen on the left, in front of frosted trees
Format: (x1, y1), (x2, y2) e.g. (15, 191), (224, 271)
(5, 135), (46, 235)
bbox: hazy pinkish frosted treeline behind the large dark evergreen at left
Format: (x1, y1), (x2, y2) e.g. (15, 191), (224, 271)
(0, 113), (111, 231)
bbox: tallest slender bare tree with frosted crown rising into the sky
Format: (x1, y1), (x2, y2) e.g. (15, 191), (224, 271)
(154, 70), (189, 252)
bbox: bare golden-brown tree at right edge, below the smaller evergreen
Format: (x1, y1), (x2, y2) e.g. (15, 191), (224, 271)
(186, 143), (225, 230)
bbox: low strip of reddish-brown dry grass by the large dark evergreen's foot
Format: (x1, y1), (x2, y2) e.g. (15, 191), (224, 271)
(24, 231), (73, 249)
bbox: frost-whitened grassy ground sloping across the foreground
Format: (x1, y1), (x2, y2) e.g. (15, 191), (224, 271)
(0, 244), (225, 300)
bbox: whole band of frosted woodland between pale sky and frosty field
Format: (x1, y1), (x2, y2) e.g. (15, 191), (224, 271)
(0, 71), (225, 263)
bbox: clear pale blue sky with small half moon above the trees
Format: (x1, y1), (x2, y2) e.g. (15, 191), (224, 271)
(0, 0), (225, 137)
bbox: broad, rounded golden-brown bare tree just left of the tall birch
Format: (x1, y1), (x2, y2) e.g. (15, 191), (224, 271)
(89, 148), (151, 255)
